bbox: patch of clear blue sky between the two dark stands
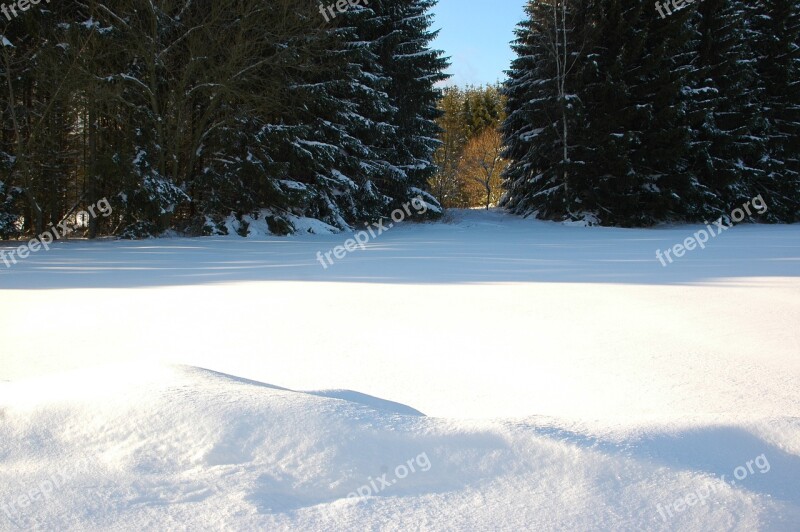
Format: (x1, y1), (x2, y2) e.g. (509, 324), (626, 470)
(433, 0), (525, 86)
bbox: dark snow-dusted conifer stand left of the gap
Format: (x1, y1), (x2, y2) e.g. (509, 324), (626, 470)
(0, 0), (447, 238)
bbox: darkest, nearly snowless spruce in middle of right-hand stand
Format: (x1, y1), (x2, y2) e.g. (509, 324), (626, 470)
(613, 4), (698, 225)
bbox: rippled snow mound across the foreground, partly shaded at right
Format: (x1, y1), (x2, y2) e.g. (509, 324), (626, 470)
(0, 363), (800, 531)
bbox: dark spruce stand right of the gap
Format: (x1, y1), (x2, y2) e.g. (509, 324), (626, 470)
(502, 0), (800, 226)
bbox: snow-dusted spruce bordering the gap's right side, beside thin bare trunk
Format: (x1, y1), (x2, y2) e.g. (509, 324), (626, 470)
(501, 0), (577, 219)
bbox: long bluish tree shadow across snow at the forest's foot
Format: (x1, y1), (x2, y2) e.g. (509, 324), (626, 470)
(0, 212), (800, 289)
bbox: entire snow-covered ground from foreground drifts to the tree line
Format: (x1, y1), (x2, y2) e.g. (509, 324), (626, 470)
(0, 211), (800, 531)
